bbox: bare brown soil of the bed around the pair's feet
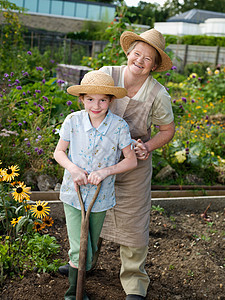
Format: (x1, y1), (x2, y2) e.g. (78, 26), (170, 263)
(0, 211), (225, 300)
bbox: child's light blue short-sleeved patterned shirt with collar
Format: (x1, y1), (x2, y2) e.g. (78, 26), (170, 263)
(59, 110), (132, 212)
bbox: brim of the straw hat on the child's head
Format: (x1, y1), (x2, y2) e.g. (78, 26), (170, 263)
(67, 85), (127, 99)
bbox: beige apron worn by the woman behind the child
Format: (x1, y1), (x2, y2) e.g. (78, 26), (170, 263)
(101, 67), (161, 247)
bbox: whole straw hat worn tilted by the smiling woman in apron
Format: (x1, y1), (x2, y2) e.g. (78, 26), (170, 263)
(120, 28), (173, 72)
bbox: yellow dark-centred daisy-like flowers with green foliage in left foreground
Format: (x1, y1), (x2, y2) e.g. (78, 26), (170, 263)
(0, 162), (60, 285)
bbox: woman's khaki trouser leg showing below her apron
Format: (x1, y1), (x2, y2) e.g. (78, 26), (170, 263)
(120, 245), (150, 297)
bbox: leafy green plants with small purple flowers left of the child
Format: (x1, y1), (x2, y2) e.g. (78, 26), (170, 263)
(0, 51), (80, 175)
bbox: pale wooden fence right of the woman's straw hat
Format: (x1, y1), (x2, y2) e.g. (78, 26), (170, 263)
(167, 44), (225, 67)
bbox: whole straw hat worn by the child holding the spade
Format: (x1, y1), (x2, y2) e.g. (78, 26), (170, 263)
(67, 71), (127, 99)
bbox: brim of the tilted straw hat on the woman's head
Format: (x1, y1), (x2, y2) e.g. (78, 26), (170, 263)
(120, 31), (173, 72)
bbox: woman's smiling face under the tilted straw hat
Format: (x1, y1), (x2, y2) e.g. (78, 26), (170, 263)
(127, 42), (157, 77)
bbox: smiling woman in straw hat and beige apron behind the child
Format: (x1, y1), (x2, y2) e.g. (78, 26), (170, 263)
(100, 29), (175, 300)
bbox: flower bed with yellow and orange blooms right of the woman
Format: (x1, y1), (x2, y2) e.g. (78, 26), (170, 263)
(153, 66), (225, 184)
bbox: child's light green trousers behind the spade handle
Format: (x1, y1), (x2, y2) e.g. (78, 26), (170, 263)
(64, 203), (106, 271)
